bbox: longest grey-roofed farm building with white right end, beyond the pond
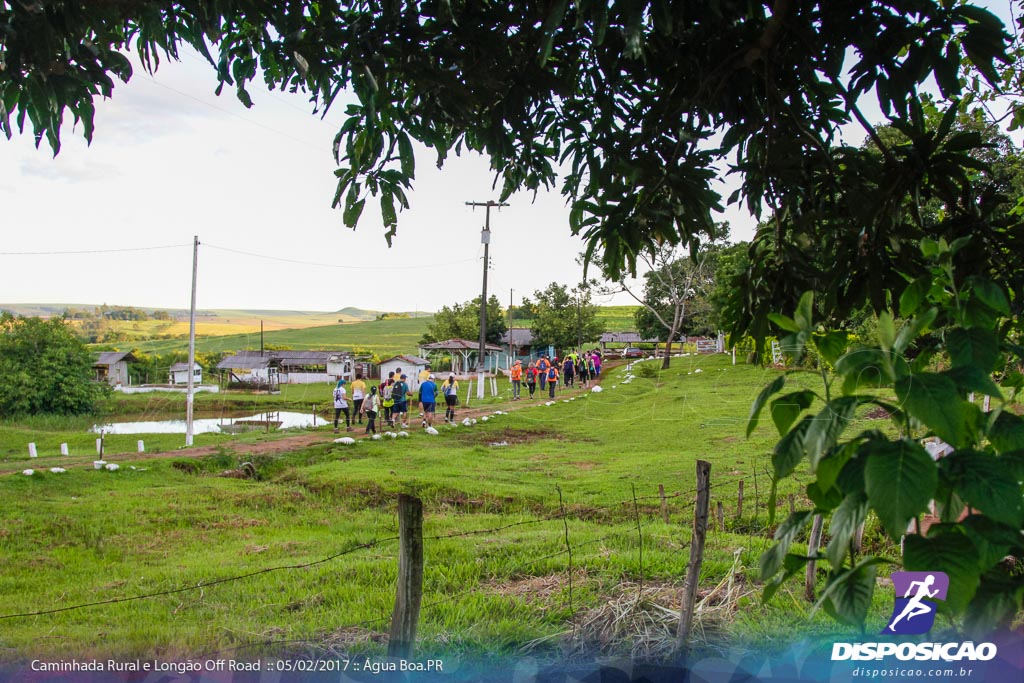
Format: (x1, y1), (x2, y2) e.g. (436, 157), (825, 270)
(217, 350), (354, 384)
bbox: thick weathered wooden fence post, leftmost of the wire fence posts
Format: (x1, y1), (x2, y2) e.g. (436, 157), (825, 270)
(387, 494), (423, 659)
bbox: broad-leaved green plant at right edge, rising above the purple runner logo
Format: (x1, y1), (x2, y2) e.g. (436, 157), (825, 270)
(748, 238), (1024, 633)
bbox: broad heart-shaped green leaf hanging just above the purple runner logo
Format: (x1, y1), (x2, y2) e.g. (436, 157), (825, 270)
(864, 439), (938, 540)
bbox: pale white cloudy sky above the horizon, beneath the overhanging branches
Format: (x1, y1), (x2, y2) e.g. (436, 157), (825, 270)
(0, 3), (1015, 311)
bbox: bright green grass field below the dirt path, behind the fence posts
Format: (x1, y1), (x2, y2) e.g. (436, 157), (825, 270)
(0, 356), (905, 660)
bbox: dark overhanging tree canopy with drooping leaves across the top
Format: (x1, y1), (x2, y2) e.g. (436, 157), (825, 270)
(0, 0), (1008, 292)
